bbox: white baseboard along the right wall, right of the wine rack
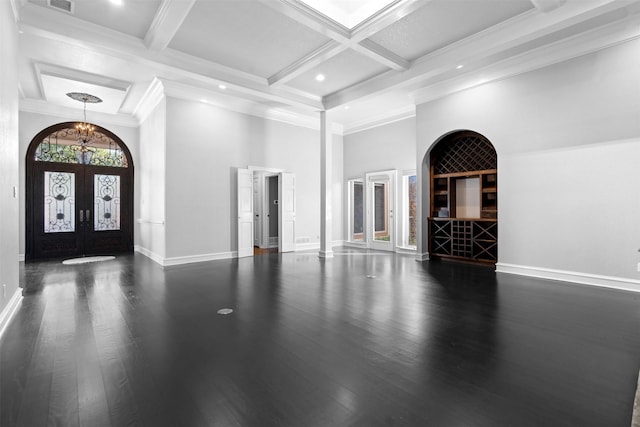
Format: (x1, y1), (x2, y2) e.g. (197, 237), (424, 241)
(496, 262), (640, 292)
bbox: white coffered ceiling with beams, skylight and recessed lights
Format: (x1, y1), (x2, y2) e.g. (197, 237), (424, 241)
(11, 0), (640, 132)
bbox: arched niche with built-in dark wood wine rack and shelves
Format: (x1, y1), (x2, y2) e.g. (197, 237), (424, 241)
(428, 131), (498, 264)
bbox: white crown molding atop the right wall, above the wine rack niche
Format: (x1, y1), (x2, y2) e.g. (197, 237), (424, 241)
(410, 14), (640, 105)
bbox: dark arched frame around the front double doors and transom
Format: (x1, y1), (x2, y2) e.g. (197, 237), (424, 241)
(25, 122), (135, 261)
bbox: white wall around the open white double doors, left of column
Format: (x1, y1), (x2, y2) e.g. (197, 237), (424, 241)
(166, 97), (342, 260)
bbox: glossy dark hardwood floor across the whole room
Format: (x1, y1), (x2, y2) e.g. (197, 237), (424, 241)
(0, 249), (640, 427)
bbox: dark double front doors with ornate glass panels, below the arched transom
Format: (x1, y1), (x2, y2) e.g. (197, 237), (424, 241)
(27, 162), (133, 259)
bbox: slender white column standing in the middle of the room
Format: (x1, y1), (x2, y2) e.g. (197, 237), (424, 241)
(318, 111), (333, 258)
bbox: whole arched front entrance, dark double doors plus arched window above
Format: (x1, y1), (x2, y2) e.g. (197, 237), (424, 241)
(25, 122), (133, 260)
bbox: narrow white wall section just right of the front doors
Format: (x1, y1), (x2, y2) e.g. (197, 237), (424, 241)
(135, 99), (166, 262)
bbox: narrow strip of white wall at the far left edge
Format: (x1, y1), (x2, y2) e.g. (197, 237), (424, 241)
(0, 1), (21, 312)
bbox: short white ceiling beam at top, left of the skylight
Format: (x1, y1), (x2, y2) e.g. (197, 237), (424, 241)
(144, 0), (196, 51)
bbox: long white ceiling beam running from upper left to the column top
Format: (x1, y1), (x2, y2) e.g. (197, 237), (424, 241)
(21, 4), (324, 111)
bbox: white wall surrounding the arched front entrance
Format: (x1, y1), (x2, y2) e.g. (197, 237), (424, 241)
(19, 111), (139, 255)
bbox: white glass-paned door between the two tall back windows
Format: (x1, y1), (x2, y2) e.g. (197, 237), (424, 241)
(366, 171), (396, 251)
